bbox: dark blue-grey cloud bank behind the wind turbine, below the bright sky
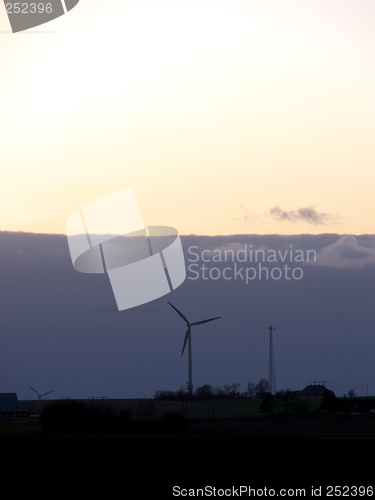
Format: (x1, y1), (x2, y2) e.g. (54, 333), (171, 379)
(0, 232), (375, 399)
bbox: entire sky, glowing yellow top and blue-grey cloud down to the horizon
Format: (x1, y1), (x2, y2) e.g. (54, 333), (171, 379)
(0, 0), (375, 398)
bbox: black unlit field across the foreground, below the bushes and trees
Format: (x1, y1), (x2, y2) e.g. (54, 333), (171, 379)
(0, 415), (375, 500)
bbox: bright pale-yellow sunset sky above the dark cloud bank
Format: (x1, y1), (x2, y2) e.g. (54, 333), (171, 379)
(0, 0), (375, 235)
